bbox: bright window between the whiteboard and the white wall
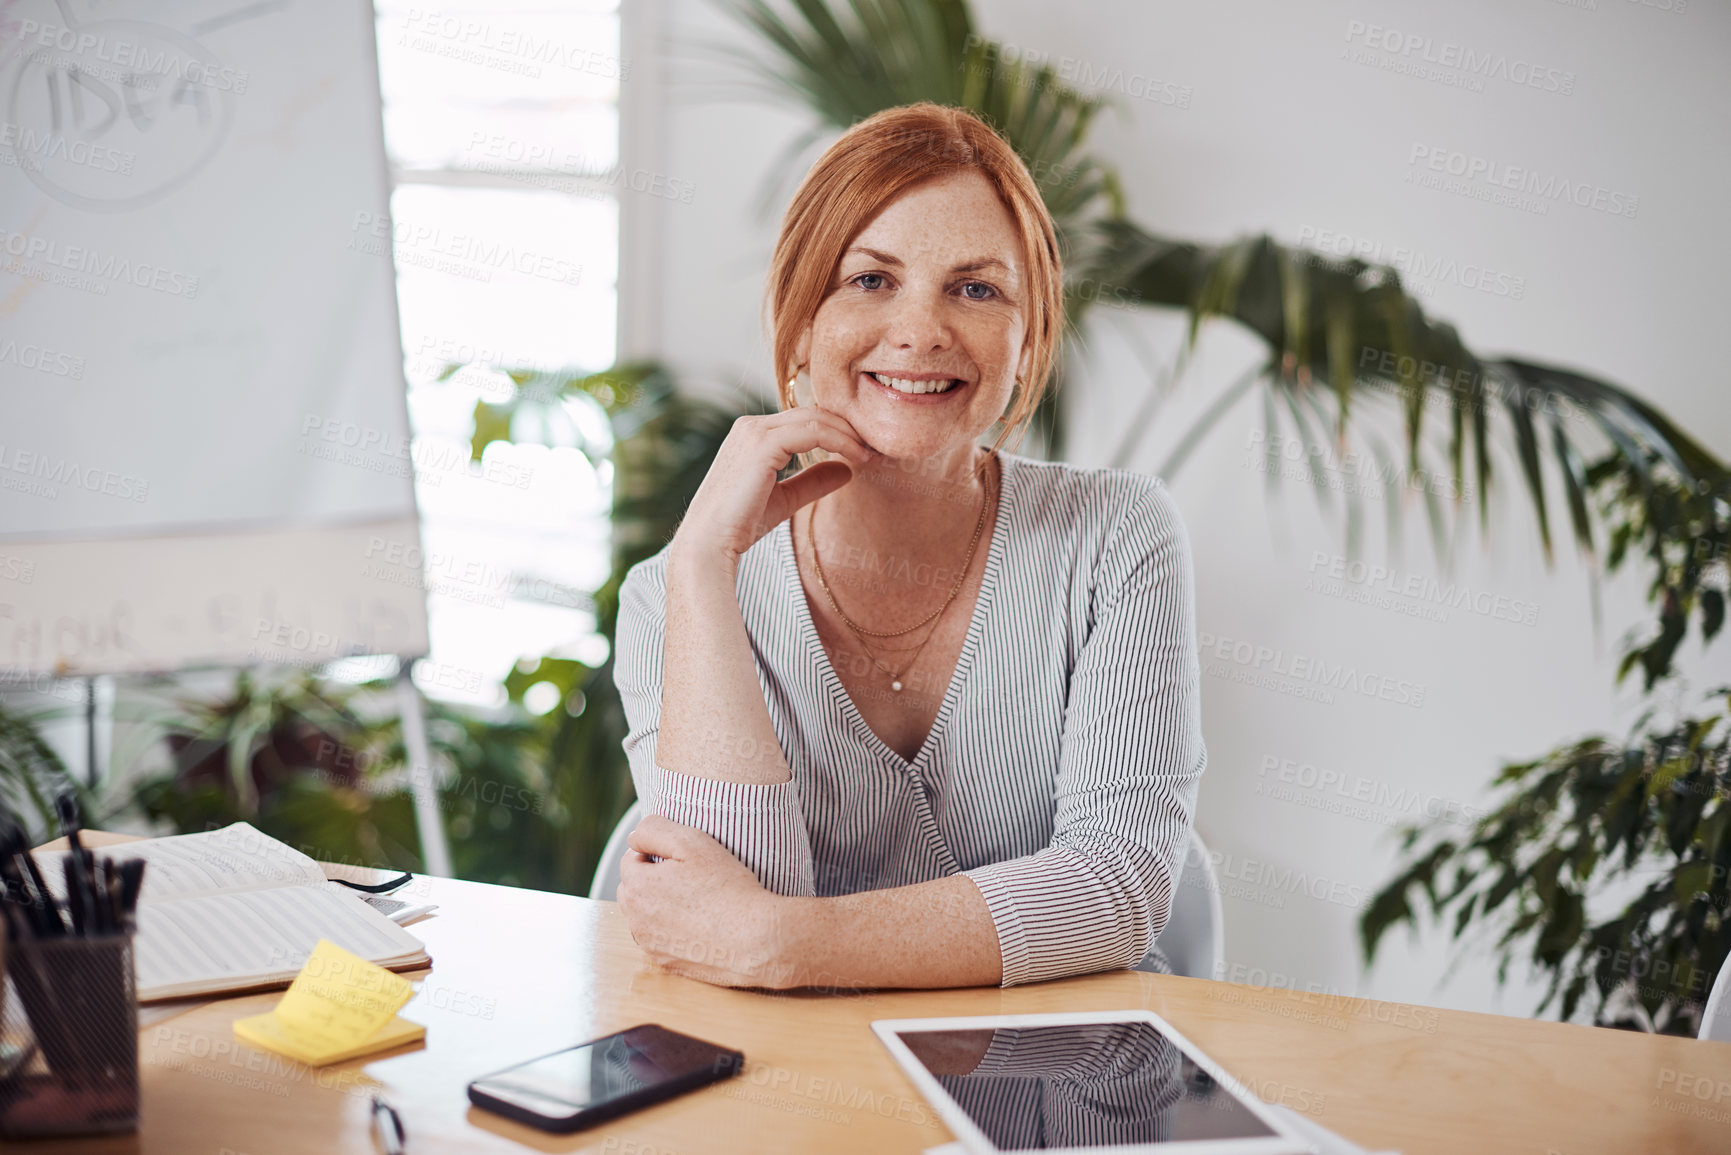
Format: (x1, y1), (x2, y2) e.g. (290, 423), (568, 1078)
(376, 0), (625, 707)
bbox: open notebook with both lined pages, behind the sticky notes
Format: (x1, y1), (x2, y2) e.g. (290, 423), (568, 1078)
(35, 823), (433, 1003)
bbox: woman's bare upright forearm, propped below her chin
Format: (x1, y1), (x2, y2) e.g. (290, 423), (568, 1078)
(656, 542), (791, 784)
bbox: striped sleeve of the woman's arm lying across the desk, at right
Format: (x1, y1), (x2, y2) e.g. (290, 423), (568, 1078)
(964, 481), (1207, 987)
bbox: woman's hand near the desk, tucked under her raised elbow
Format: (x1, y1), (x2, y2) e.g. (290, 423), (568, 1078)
(618, 814), (798, 990)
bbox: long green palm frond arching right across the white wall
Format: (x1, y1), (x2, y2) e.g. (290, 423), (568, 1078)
(1087, 220), (1728, 567)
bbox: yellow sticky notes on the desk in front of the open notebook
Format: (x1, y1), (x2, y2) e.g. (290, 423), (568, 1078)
(235, 939), (414, 1063)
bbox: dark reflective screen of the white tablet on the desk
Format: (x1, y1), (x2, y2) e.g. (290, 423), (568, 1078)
(898, 1022), (1276, 1152)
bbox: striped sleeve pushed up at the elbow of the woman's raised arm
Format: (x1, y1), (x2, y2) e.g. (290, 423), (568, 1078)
(613, 554), (817, 895)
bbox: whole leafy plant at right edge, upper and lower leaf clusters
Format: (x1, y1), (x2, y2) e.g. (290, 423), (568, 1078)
(1359, 461), (1731, 1036)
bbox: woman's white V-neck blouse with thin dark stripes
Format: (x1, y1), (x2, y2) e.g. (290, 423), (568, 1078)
(615, 454), (1207, 987)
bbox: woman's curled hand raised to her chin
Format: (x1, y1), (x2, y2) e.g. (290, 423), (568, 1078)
(672, 407), (878, 571)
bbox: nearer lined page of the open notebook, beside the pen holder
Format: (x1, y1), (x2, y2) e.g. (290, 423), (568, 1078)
(135, 886), (426, 1001)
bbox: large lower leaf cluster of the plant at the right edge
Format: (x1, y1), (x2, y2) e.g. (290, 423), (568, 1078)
(1361, 691), (1731, 1036)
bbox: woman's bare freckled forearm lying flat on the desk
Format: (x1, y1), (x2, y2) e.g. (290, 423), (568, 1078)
(777, 874), (1004, 987)
